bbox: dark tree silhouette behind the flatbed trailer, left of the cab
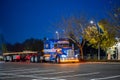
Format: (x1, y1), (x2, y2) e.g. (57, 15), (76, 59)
(6, 38), (43, 52)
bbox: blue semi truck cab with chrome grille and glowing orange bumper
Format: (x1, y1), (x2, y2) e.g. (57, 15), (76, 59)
(43, 39), (79, 63)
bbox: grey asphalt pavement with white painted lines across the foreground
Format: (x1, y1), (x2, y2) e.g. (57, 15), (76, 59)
(0, 62), (120, 80)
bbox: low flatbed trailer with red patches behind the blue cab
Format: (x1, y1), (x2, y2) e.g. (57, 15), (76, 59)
(3, 51), (38, 62)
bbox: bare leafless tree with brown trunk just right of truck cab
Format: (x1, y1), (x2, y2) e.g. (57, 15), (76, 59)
(57, 17), (88, 59)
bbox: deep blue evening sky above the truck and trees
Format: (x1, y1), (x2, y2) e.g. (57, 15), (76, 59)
(0, 0), (120, 43)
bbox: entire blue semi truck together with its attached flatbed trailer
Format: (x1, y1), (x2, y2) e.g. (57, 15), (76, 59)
(3, 39), (79, 63)
